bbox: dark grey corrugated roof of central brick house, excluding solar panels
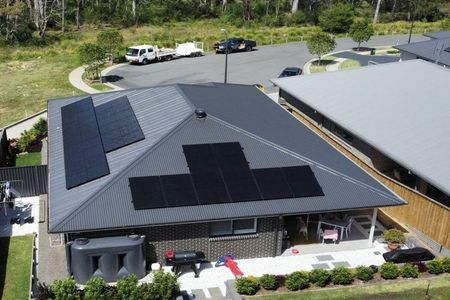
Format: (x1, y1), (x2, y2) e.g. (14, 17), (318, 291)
(48, 84), (406, 232)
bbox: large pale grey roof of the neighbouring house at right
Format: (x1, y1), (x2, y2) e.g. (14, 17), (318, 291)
(273, 60), (450, 195)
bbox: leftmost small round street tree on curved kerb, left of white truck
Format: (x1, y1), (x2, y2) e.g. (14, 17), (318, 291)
(78, 43), (105, 79)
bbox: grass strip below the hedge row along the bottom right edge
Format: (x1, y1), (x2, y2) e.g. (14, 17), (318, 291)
(256, 276), (450, 300)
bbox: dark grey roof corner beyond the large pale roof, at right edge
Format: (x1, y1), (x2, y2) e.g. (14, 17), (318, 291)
(394, 38), (450, 66)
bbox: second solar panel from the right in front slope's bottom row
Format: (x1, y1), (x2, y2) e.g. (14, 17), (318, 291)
(252, 168), (294, 200)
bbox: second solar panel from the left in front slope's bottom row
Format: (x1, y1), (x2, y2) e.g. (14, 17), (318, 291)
(160, 174), (199, 206)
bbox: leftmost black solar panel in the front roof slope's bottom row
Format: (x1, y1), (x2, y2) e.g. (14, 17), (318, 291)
(128, 176), (167, 209)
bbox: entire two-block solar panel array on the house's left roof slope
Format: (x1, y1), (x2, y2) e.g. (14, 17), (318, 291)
(61, 97), (144, 189)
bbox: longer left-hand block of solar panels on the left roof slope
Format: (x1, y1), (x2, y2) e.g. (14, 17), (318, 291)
(61, 97), (109, 189)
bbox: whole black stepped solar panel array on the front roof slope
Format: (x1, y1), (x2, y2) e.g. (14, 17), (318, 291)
(129, 142), (324, 209)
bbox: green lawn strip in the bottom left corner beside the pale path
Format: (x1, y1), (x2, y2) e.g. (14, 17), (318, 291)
(0, 236), (33, 300)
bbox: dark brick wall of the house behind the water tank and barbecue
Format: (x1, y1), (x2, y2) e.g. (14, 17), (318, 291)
(69, 217), (283, 262)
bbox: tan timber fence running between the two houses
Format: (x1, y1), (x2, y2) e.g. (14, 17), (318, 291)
(285, 105), (450, 249)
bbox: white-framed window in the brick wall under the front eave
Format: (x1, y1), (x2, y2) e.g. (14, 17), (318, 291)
(209, 218), (257, 236)
